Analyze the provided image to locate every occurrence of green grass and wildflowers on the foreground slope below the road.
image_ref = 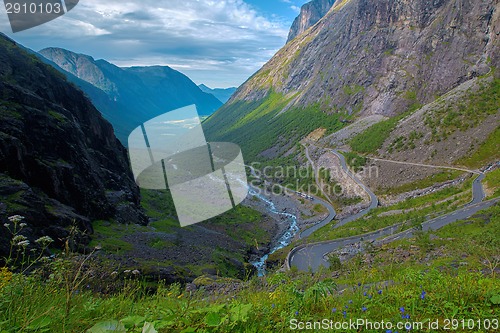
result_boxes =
[0,205,500,332]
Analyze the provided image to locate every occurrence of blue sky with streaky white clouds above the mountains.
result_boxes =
[0,0,308,88]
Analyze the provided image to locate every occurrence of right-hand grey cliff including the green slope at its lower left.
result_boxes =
[204,0,500,159]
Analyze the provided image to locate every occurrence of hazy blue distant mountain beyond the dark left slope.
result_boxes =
[40,48,222,144]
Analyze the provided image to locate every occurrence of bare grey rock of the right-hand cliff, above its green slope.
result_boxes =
[232,0,500,115]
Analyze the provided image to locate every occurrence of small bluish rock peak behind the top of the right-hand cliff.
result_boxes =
[287,0,336,43]
